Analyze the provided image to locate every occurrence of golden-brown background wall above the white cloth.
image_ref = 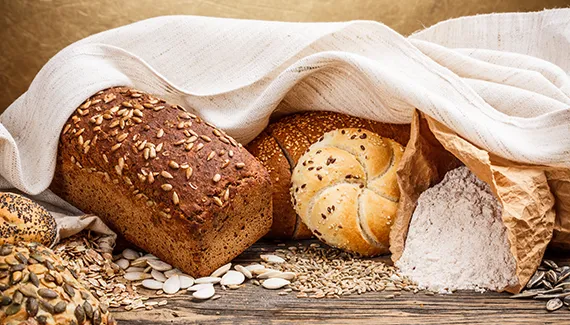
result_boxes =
[0,0,570,111]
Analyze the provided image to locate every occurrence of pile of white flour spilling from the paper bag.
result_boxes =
[396,167,516,293]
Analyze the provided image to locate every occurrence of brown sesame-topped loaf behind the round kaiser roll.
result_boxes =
[247,112,410,239]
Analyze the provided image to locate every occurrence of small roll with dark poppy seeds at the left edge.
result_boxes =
[0,193,57,247]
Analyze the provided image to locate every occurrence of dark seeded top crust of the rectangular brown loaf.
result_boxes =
[61,87,268,226]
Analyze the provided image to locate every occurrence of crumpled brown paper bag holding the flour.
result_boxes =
[390,112,570,293]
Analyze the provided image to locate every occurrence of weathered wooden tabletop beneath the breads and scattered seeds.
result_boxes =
[114,242,570,325]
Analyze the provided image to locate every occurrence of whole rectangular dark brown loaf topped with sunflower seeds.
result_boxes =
[51,88,272,276]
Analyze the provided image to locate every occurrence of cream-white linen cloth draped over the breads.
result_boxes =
[0,9,570,242]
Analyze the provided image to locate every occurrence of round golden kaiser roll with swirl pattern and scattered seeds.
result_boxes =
[291,129,404,256]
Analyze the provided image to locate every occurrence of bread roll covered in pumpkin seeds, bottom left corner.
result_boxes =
[0,242,116,325]
